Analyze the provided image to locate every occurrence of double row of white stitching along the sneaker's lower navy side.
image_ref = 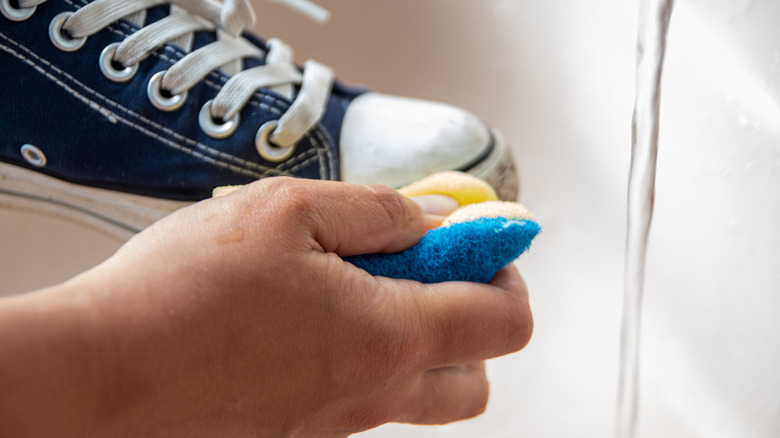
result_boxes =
[0,33,325,178]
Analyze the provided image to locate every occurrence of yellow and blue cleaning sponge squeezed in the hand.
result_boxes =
[344,182,540,283]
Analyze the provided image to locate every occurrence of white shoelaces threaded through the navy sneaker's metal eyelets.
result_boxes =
[19,0,333,147]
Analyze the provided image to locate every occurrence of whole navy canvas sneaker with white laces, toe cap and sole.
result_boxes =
[0,0,517,237]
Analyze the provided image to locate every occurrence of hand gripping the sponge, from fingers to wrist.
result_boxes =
[0,178,533,437]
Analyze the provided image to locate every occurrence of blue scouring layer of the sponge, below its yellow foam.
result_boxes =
[344,217,539,283]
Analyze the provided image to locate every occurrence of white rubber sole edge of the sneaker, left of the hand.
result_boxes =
[0,163,191,240]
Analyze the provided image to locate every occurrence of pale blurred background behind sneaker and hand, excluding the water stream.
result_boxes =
[0,0,780,438]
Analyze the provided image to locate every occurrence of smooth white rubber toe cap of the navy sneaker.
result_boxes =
[340,93,490,187]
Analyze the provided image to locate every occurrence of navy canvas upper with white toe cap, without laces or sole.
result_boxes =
[0,0,512,201]
